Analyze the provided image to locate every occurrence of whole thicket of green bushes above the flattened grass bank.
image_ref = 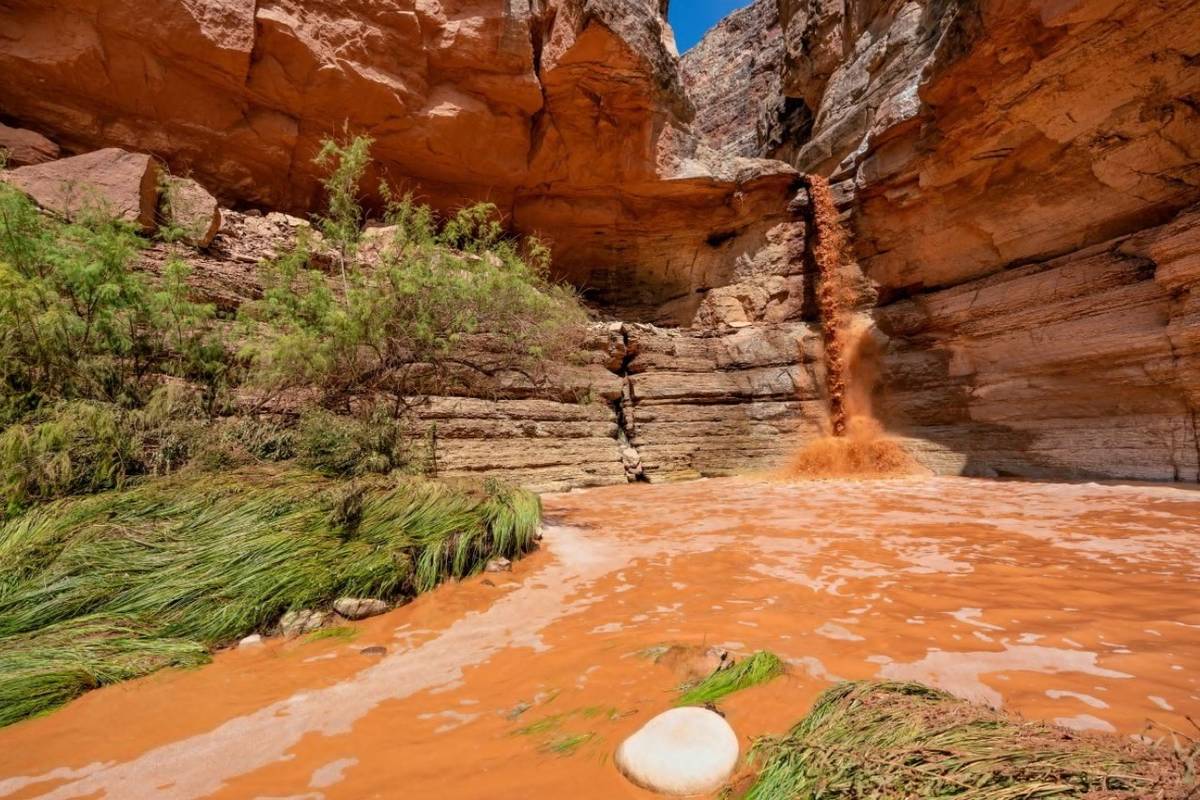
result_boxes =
[0,138,586,515]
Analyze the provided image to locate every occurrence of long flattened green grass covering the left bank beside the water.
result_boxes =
[0,470,541,726]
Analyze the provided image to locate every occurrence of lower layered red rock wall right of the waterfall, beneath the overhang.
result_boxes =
[875,209,1200,481]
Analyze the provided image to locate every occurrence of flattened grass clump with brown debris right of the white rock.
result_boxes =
[744,681,1186,800]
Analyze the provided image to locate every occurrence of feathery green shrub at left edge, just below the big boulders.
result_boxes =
[0,179,226,423]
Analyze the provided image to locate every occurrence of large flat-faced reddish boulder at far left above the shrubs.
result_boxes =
[4,148,158,230]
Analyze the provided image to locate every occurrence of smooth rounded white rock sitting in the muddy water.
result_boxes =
[616,708,738,796]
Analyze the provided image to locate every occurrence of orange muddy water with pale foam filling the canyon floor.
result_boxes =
[0,479,1200,800]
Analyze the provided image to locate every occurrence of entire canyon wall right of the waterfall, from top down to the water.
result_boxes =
[684,0,1200,481]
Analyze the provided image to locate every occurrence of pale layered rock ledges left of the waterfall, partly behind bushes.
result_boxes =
[142,210,824,491]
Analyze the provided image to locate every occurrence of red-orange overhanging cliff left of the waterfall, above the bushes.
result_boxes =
[0,0,796,324]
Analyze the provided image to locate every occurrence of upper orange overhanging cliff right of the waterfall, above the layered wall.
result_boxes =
[685,0,1200,296]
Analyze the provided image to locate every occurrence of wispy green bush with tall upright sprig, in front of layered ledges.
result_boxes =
[244,138,584,416]
